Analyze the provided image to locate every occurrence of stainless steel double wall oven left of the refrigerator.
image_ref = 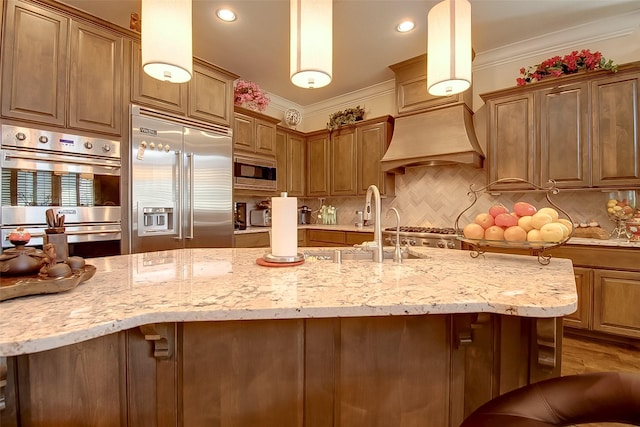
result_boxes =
[0,125,122,258]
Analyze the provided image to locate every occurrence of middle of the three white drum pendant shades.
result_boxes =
[289,0,333,88]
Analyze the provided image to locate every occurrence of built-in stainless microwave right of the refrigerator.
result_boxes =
[233,155,276,191]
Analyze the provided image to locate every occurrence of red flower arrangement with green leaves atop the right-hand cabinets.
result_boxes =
[516,49,618,86]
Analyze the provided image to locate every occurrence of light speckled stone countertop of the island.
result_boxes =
[0,248,577,356]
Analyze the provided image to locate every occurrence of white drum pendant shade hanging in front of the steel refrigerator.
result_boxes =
[141,0,193,83]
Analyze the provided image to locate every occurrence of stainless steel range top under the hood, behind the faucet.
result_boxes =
[382,226,462,249]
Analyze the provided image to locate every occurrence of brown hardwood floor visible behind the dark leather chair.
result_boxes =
[562,335,640,427]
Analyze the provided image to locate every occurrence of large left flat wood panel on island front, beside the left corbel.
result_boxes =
[179,320,304,427]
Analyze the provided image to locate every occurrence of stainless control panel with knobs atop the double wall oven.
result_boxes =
[2,125,120,159]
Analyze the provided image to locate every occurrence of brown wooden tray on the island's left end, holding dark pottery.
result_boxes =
[0,264,96,301]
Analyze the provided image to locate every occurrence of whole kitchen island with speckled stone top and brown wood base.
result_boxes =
[0,248,577,427]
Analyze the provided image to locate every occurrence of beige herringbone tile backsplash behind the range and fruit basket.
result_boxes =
[299,165,614,231]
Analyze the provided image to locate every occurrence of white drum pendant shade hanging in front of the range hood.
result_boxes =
[427,0,472,96]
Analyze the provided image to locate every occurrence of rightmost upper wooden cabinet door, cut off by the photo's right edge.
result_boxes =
[591,72,640,187]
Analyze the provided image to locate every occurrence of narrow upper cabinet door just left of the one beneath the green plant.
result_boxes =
[306,131,330,197]
